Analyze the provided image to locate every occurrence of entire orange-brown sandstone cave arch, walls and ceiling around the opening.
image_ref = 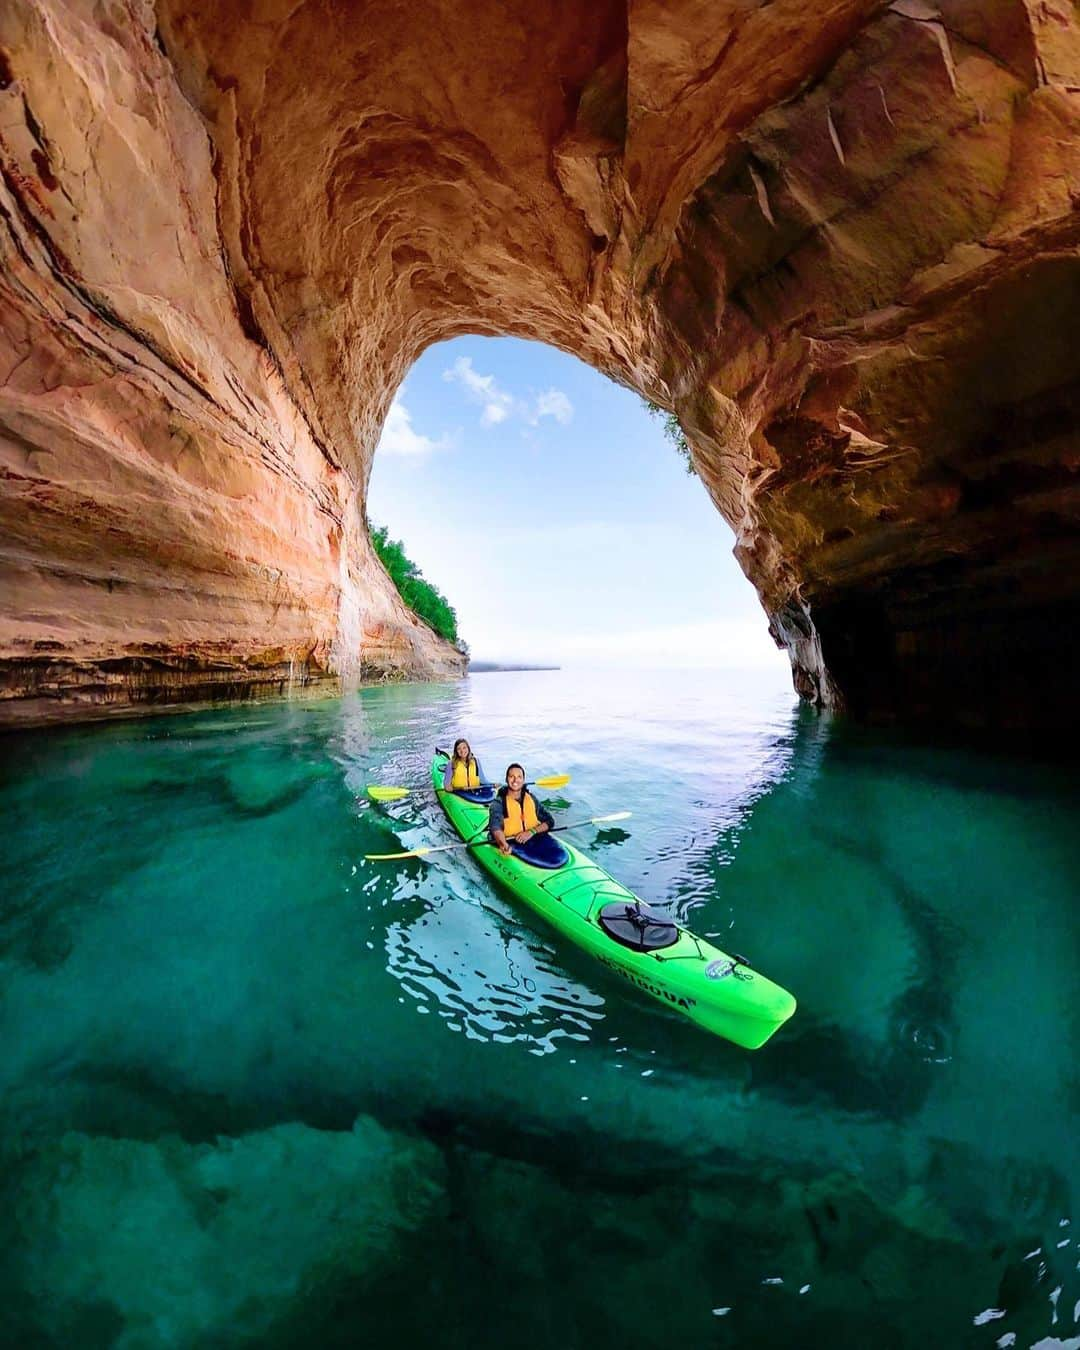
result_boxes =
[0,0,1080,729]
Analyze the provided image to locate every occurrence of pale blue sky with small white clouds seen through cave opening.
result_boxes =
[367,338,787,671]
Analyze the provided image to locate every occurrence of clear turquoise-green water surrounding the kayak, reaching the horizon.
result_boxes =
[0,671,1080,1350]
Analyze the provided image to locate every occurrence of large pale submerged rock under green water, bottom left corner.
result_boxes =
[14,1118,443,1350]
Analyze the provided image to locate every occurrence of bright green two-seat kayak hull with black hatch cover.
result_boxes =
[431,752,795,1050]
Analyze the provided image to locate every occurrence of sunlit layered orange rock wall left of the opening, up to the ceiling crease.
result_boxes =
[0,4,463,722]
